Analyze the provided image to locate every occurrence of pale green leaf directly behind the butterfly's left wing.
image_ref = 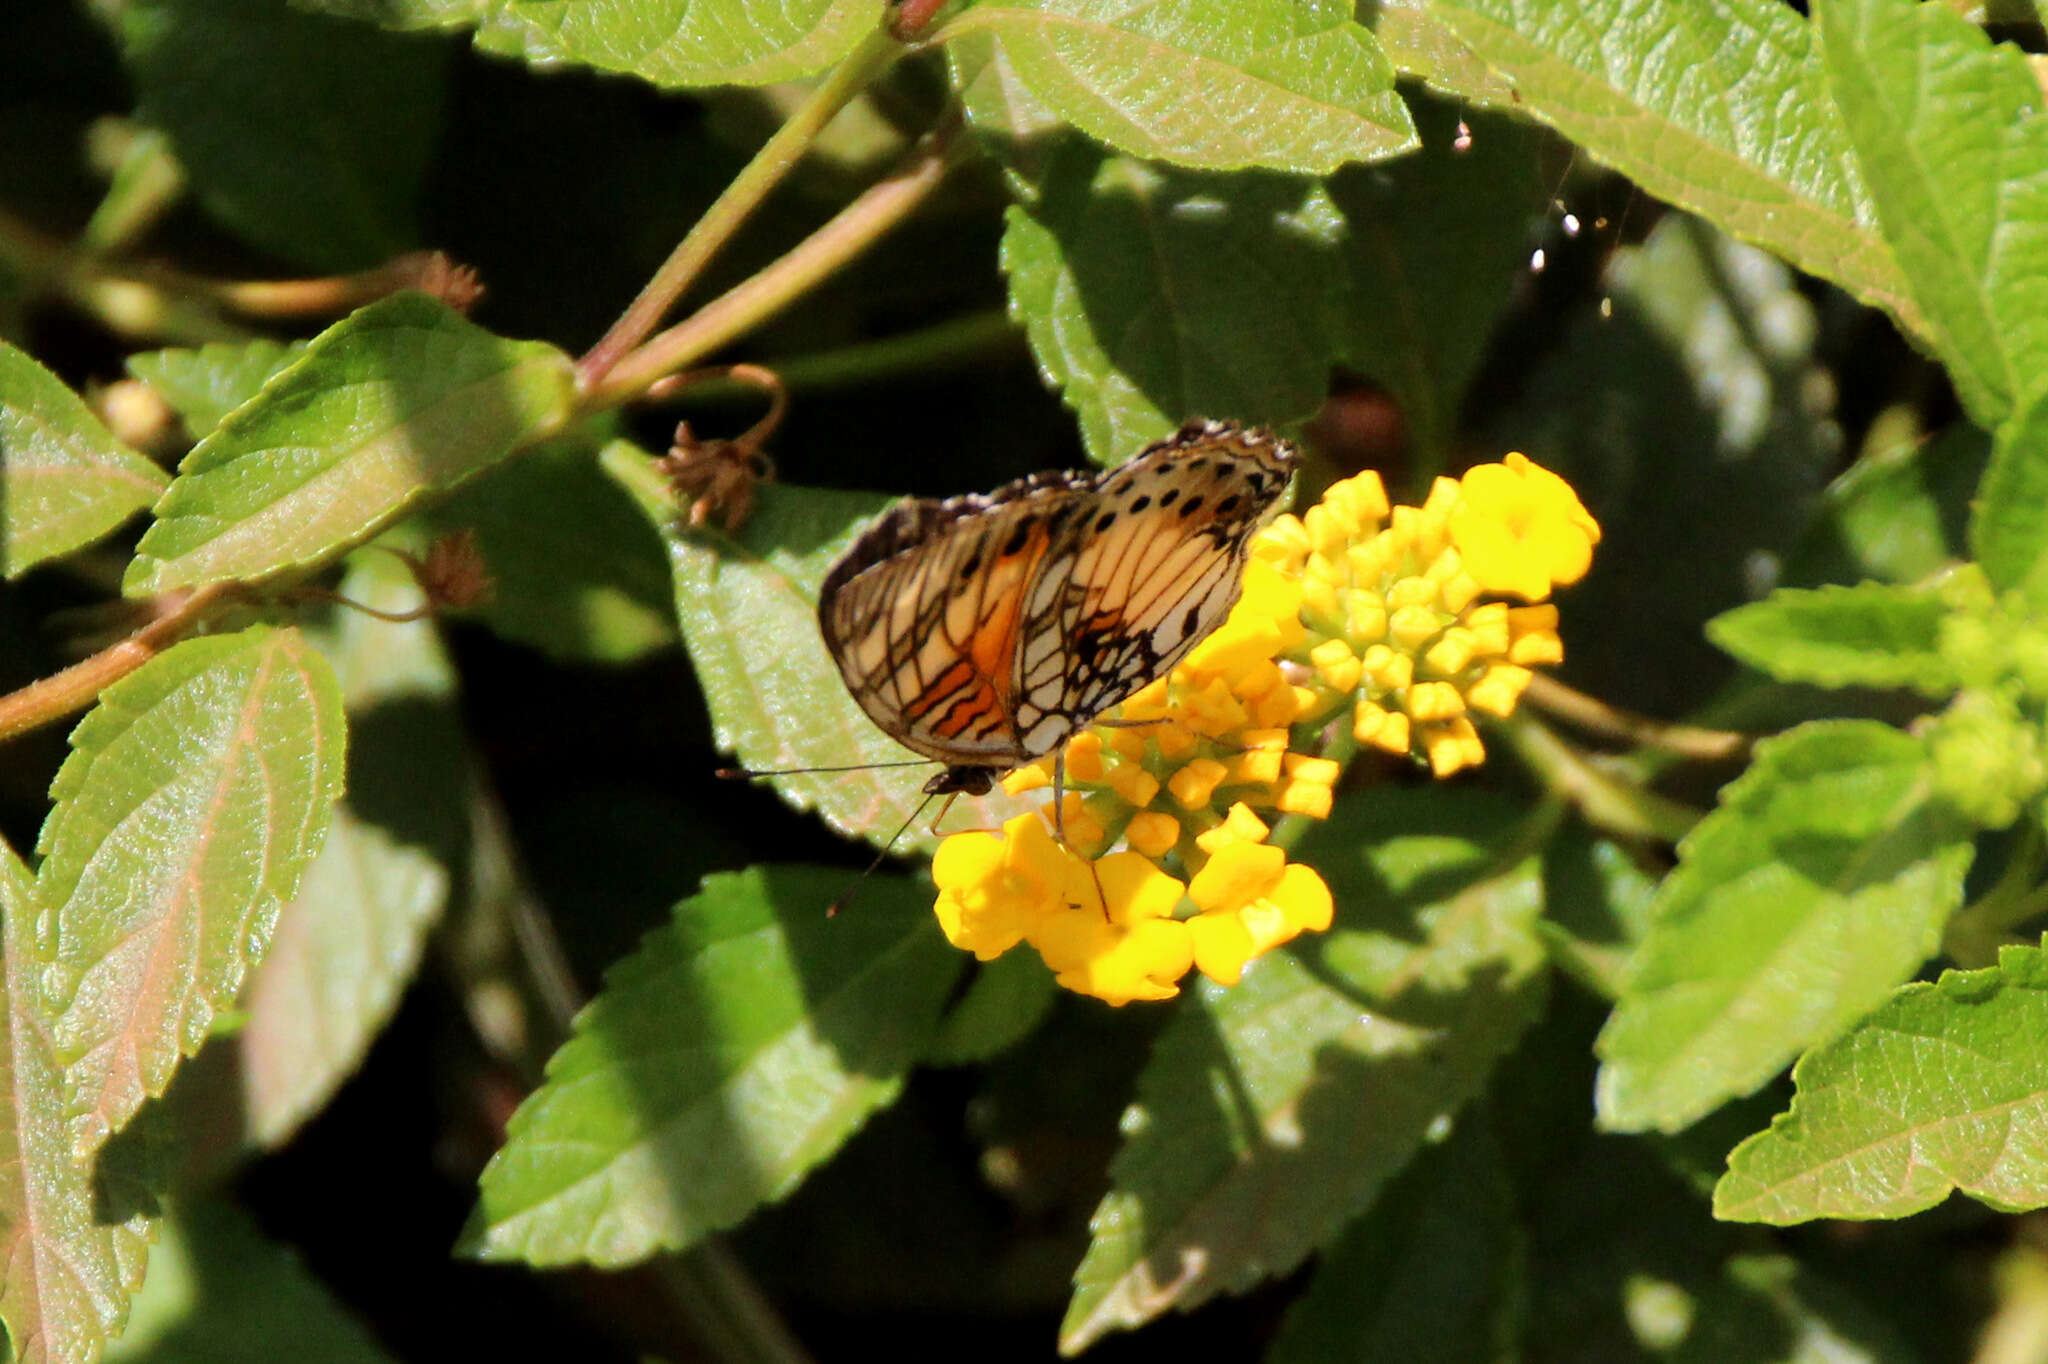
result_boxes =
[604,442,1028,850]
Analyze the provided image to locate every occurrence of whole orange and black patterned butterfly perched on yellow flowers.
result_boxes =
[817,420,1300,797]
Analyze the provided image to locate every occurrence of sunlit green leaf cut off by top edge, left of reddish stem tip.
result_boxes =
[477,0,883,88]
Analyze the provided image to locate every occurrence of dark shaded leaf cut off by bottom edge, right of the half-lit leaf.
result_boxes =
[1266,1120,1522,1364]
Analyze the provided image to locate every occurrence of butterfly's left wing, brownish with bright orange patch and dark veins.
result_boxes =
[817,473,1090,768]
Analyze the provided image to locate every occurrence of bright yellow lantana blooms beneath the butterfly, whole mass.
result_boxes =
[932,455,1599,1004]
